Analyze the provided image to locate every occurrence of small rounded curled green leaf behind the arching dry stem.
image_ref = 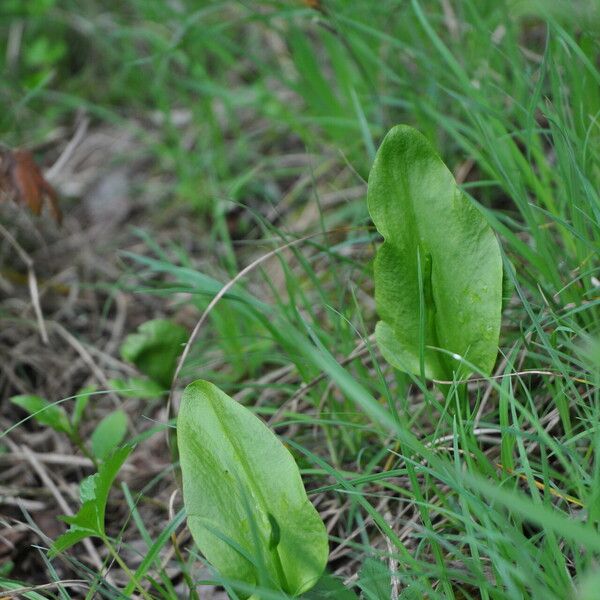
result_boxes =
[121,319,188,388]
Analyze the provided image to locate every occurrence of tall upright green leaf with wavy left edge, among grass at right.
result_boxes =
[368,125,502,379]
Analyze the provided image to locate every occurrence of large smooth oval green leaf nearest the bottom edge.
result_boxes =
[177,381,328,595]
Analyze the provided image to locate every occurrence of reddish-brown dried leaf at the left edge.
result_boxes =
[0,148,62,224]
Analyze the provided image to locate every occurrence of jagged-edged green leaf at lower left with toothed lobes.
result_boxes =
[48,446,133,558]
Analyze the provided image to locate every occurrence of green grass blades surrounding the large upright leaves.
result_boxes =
[0,0,600,600]
